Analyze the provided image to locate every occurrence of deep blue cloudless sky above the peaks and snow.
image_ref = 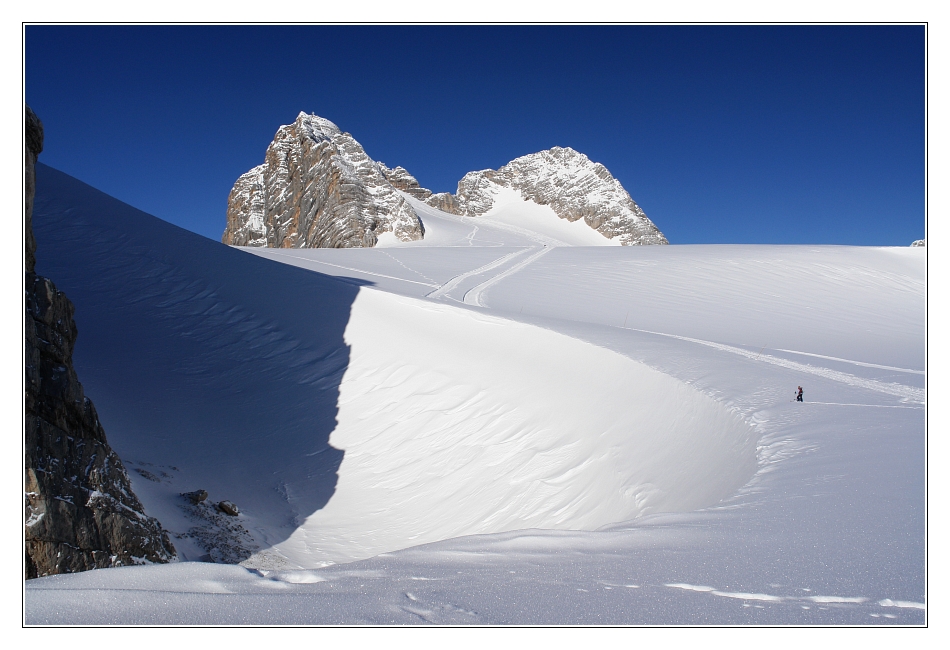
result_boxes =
[26,26,925,246]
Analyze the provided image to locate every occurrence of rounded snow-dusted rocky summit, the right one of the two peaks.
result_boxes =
[455,147,669,246]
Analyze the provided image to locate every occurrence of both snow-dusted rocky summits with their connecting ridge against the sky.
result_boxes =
[222,113,669,248]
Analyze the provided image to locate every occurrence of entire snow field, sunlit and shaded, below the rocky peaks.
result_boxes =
[25,165,927,625]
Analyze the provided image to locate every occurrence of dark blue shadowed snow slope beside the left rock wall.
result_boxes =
[33,164,365,565]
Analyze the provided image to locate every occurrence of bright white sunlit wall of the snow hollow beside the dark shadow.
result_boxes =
[276,290,755,566]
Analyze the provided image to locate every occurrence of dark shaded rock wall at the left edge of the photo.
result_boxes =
[24,108,175,578]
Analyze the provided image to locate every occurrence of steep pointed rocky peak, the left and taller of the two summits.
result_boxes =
[221,113,423,248]
